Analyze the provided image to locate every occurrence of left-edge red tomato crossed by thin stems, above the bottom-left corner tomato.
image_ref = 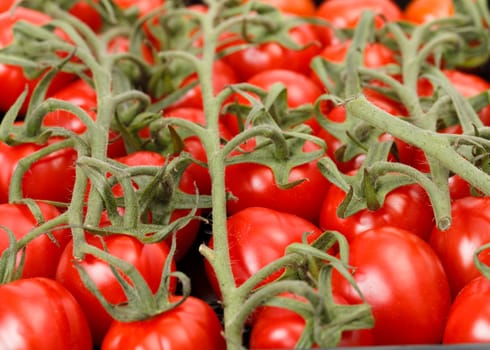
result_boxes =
[0,202,71,278]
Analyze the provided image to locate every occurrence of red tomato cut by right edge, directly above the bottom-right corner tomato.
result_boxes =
[430,197,490,296]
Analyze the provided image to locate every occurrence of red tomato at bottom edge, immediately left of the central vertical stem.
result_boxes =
[101,296,226,350]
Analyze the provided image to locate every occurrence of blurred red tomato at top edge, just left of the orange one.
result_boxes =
[316,0,402,46]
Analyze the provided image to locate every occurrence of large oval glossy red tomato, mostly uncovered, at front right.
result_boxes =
[332,226,451,345]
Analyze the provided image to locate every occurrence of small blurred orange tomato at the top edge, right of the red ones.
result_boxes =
[403,0,454,24]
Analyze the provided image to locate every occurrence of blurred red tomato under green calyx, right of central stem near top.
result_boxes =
[223,21,321,81]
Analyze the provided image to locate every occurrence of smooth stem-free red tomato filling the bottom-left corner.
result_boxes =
[0,277,93,350]
